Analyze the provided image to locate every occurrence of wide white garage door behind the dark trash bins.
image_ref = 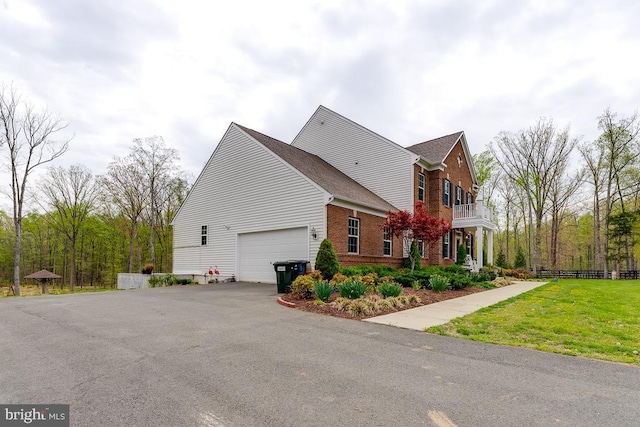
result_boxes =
[238,227,309,283]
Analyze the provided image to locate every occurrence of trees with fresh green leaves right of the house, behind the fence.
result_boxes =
[474,109,640,277]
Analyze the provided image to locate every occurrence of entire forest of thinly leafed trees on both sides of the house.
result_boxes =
[0,85,640,294]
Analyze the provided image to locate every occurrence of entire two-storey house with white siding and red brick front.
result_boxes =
[173,106,492,283]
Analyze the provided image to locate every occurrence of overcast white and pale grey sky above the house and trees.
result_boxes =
[0,0,640,182]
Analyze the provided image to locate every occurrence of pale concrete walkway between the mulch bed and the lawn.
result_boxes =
[364,282,547,331]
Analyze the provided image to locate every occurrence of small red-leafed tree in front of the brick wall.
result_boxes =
[385,202,451,271]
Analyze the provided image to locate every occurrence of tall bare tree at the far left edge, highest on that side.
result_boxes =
[0,85,70,295]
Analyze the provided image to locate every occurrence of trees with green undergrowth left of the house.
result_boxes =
[0,85,189,295]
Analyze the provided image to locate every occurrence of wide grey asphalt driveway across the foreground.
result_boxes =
[0,283,640,427]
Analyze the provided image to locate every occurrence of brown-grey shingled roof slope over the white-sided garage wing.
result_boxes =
[236,123,398,211]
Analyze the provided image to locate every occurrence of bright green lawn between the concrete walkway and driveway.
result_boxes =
[426,279,640,365]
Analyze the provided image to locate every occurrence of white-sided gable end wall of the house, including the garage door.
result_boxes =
[173,124,326,283]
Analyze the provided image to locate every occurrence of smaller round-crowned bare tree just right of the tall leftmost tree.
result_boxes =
[41,165,97,292]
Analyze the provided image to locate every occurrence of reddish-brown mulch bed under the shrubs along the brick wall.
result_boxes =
[281,286,487,320]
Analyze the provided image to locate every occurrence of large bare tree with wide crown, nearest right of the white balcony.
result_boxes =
[490,118,578,274]
